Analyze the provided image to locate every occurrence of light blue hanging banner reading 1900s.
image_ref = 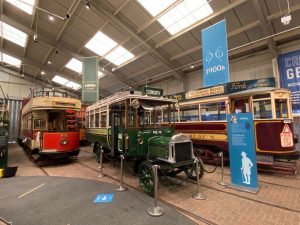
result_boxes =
[202,20,229,87]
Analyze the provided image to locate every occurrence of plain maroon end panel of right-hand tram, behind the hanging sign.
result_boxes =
[255,121,295,153]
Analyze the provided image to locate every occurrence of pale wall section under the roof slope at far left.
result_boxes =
[0,71,39,99]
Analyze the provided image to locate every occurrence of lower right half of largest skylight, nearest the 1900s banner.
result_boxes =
[158,0,213,35]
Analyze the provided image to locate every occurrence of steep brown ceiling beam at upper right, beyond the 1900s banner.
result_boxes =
[252,0,277,57]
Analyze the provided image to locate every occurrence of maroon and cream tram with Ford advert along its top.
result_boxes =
[170,78,299,173]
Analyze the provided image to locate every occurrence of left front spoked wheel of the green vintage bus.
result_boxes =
[139,161,154,195]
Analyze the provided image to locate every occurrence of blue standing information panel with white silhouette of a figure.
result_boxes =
[227,113,258,192]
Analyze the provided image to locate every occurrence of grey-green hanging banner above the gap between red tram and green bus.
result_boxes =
[82,57,99,104]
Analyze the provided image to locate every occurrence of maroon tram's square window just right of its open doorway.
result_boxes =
[253,99,272,119]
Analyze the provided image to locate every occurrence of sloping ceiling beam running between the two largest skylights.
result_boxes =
[93,1,183,82]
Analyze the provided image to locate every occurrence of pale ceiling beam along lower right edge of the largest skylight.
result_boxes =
[155,0,247,48]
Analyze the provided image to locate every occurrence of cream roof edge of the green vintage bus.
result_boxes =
[87,91,178,110]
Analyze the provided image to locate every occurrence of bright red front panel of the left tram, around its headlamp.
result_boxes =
[43,132,79,152]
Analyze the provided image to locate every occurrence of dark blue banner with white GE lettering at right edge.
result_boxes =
[278,50,300,116]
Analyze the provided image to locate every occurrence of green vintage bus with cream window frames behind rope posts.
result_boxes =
[86,91,204,194]
